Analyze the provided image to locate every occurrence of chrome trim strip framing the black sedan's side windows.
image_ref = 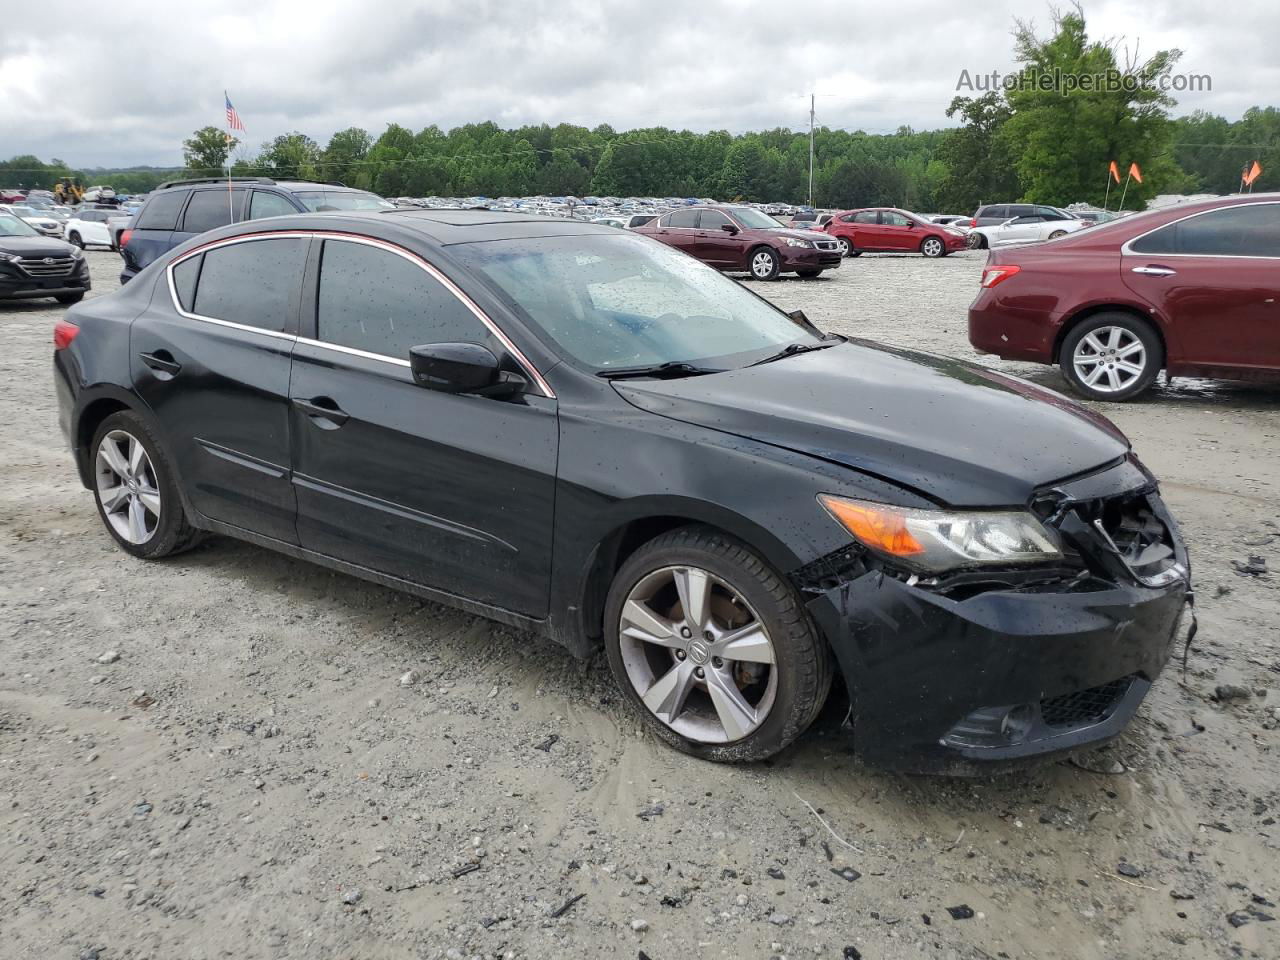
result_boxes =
[165,230,556,399]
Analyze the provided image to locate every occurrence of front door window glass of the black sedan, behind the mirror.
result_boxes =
[316,239,490,360]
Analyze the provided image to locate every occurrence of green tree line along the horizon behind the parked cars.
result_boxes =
[0,6,1280,212]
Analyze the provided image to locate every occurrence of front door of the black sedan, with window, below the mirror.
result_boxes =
[289,238,558,617]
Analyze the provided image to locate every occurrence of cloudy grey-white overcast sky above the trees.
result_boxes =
[0,0,1280,166]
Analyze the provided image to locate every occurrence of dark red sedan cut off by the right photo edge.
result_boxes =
[969,193,1280,401]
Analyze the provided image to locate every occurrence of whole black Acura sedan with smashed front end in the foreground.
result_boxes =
[47,210,1189,769]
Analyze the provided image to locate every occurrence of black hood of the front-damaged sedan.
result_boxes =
[613,342,1129,507]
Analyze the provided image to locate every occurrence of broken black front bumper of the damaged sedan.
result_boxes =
[801,461,1194,773]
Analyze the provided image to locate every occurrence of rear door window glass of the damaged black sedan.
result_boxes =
[192,238,310,333]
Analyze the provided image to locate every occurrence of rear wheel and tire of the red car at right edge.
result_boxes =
[1059,312,1165,402]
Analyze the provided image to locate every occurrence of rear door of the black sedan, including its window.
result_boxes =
[129,237,311,543]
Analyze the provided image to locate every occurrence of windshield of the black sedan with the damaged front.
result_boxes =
[449,234,819,371]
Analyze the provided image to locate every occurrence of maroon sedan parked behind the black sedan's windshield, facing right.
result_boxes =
[635,206,841,280]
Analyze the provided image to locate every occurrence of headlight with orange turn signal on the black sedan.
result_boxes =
[818,494,1062,573]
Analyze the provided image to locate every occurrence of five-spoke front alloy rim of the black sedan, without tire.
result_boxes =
[618,566,778,744]
